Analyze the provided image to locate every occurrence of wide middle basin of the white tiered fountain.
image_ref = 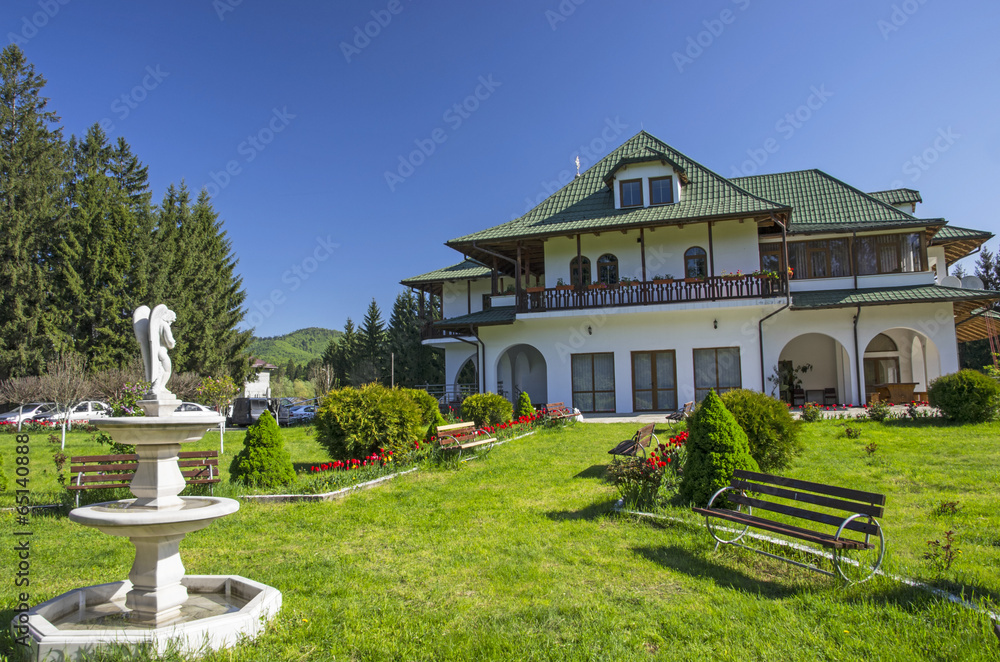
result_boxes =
[69,497,240,538]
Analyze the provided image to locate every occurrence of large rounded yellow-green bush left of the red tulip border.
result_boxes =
[315,383,424,460]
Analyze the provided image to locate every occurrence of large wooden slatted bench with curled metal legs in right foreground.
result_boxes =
[692,469,885,582]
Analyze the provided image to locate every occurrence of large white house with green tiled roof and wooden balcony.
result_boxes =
[402,131,1000,413]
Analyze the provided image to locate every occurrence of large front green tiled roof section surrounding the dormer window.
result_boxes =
[448,131,787,247]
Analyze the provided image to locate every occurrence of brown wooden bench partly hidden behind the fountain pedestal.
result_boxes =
[66,451,219,507]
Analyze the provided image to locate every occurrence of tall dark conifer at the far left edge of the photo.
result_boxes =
[0,45,68,379]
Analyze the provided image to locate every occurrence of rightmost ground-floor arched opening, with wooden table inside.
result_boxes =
[864,327,941,403]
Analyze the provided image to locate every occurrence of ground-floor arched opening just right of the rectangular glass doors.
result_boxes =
[767,333,853,405]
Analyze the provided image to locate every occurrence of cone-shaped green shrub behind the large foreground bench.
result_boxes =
[681,391,760,506]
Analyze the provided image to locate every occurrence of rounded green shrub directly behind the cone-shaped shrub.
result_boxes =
[719,388,802,472]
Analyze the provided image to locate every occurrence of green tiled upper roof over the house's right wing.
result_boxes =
[733,170,932,232]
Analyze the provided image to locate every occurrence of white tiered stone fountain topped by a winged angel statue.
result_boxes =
[12,304,281,660]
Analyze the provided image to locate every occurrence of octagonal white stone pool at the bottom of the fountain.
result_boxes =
[11,575,281,662]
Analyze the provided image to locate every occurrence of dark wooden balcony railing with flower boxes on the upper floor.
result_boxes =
[517,276,788,313]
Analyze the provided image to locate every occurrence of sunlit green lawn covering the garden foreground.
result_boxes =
[0,421,1000,661]
